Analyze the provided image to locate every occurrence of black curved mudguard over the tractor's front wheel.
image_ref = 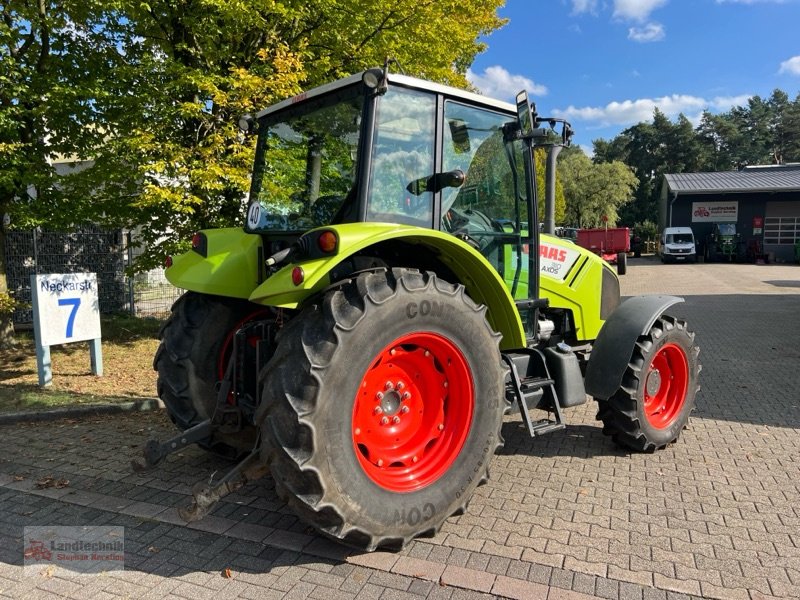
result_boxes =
[584,296,683,400]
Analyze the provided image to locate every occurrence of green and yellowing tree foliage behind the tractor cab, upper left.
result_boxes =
[0,0,503,339]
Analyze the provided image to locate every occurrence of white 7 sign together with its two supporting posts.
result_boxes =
[31,273,103,386]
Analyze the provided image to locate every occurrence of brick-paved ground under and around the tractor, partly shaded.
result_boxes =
[0,259,800,600]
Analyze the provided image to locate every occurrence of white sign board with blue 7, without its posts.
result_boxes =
[33,273,100,346]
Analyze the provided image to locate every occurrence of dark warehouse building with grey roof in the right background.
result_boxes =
[659,164,800,262]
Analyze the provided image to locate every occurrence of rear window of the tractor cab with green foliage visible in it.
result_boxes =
[246,86,364,231]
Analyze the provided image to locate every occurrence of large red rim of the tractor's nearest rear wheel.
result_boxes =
[352,333,474,492]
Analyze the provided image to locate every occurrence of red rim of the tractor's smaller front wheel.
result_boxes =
[644,344,689,429]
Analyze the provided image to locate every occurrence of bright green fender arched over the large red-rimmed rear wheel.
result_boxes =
[250,223,525,349]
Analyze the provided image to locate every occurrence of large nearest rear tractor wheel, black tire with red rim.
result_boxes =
[259,269,505,550]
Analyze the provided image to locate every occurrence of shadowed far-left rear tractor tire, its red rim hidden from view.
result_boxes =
[153,292,264,457]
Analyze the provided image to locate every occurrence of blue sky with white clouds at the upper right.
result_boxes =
[467,0,800,154]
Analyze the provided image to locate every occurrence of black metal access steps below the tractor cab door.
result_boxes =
[502,348,565,437]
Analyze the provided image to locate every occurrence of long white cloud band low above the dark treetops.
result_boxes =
[553,94,751,127]
